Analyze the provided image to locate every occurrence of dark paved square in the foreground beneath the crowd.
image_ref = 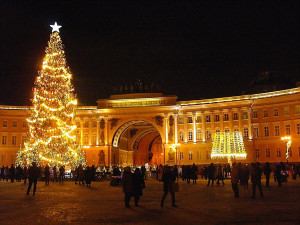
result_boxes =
[0,180,300,225]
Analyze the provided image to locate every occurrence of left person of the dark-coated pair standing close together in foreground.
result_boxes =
[122,166,134,208]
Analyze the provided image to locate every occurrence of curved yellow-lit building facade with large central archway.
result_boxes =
[0,88,300,166]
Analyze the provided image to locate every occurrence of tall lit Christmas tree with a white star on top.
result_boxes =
[16,22,85,166]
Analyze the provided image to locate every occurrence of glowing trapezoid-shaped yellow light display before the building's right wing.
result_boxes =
[211,132,247,161]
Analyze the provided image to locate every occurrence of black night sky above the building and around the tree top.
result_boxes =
[0,0,300,105]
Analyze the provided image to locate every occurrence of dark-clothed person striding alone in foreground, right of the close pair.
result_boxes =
[160,166,177,208]
